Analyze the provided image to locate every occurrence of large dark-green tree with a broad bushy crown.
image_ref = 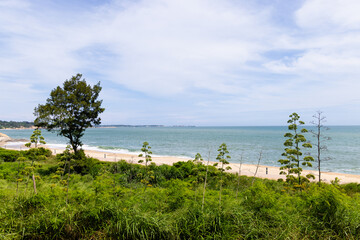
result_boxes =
[34,74,105,154]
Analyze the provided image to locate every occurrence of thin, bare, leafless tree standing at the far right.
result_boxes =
[310,111,331,183]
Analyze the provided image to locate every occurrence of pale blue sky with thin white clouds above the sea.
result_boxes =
[0,0,360,126]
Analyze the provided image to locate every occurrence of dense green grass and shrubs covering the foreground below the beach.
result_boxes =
[0,148,360,239]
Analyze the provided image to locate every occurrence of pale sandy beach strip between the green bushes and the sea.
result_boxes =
[5,144,360,184]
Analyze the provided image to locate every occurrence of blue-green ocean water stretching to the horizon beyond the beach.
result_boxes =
[1,126,360,174]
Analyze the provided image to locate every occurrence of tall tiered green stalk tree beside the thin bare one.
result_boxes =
[278,113,315,185]
